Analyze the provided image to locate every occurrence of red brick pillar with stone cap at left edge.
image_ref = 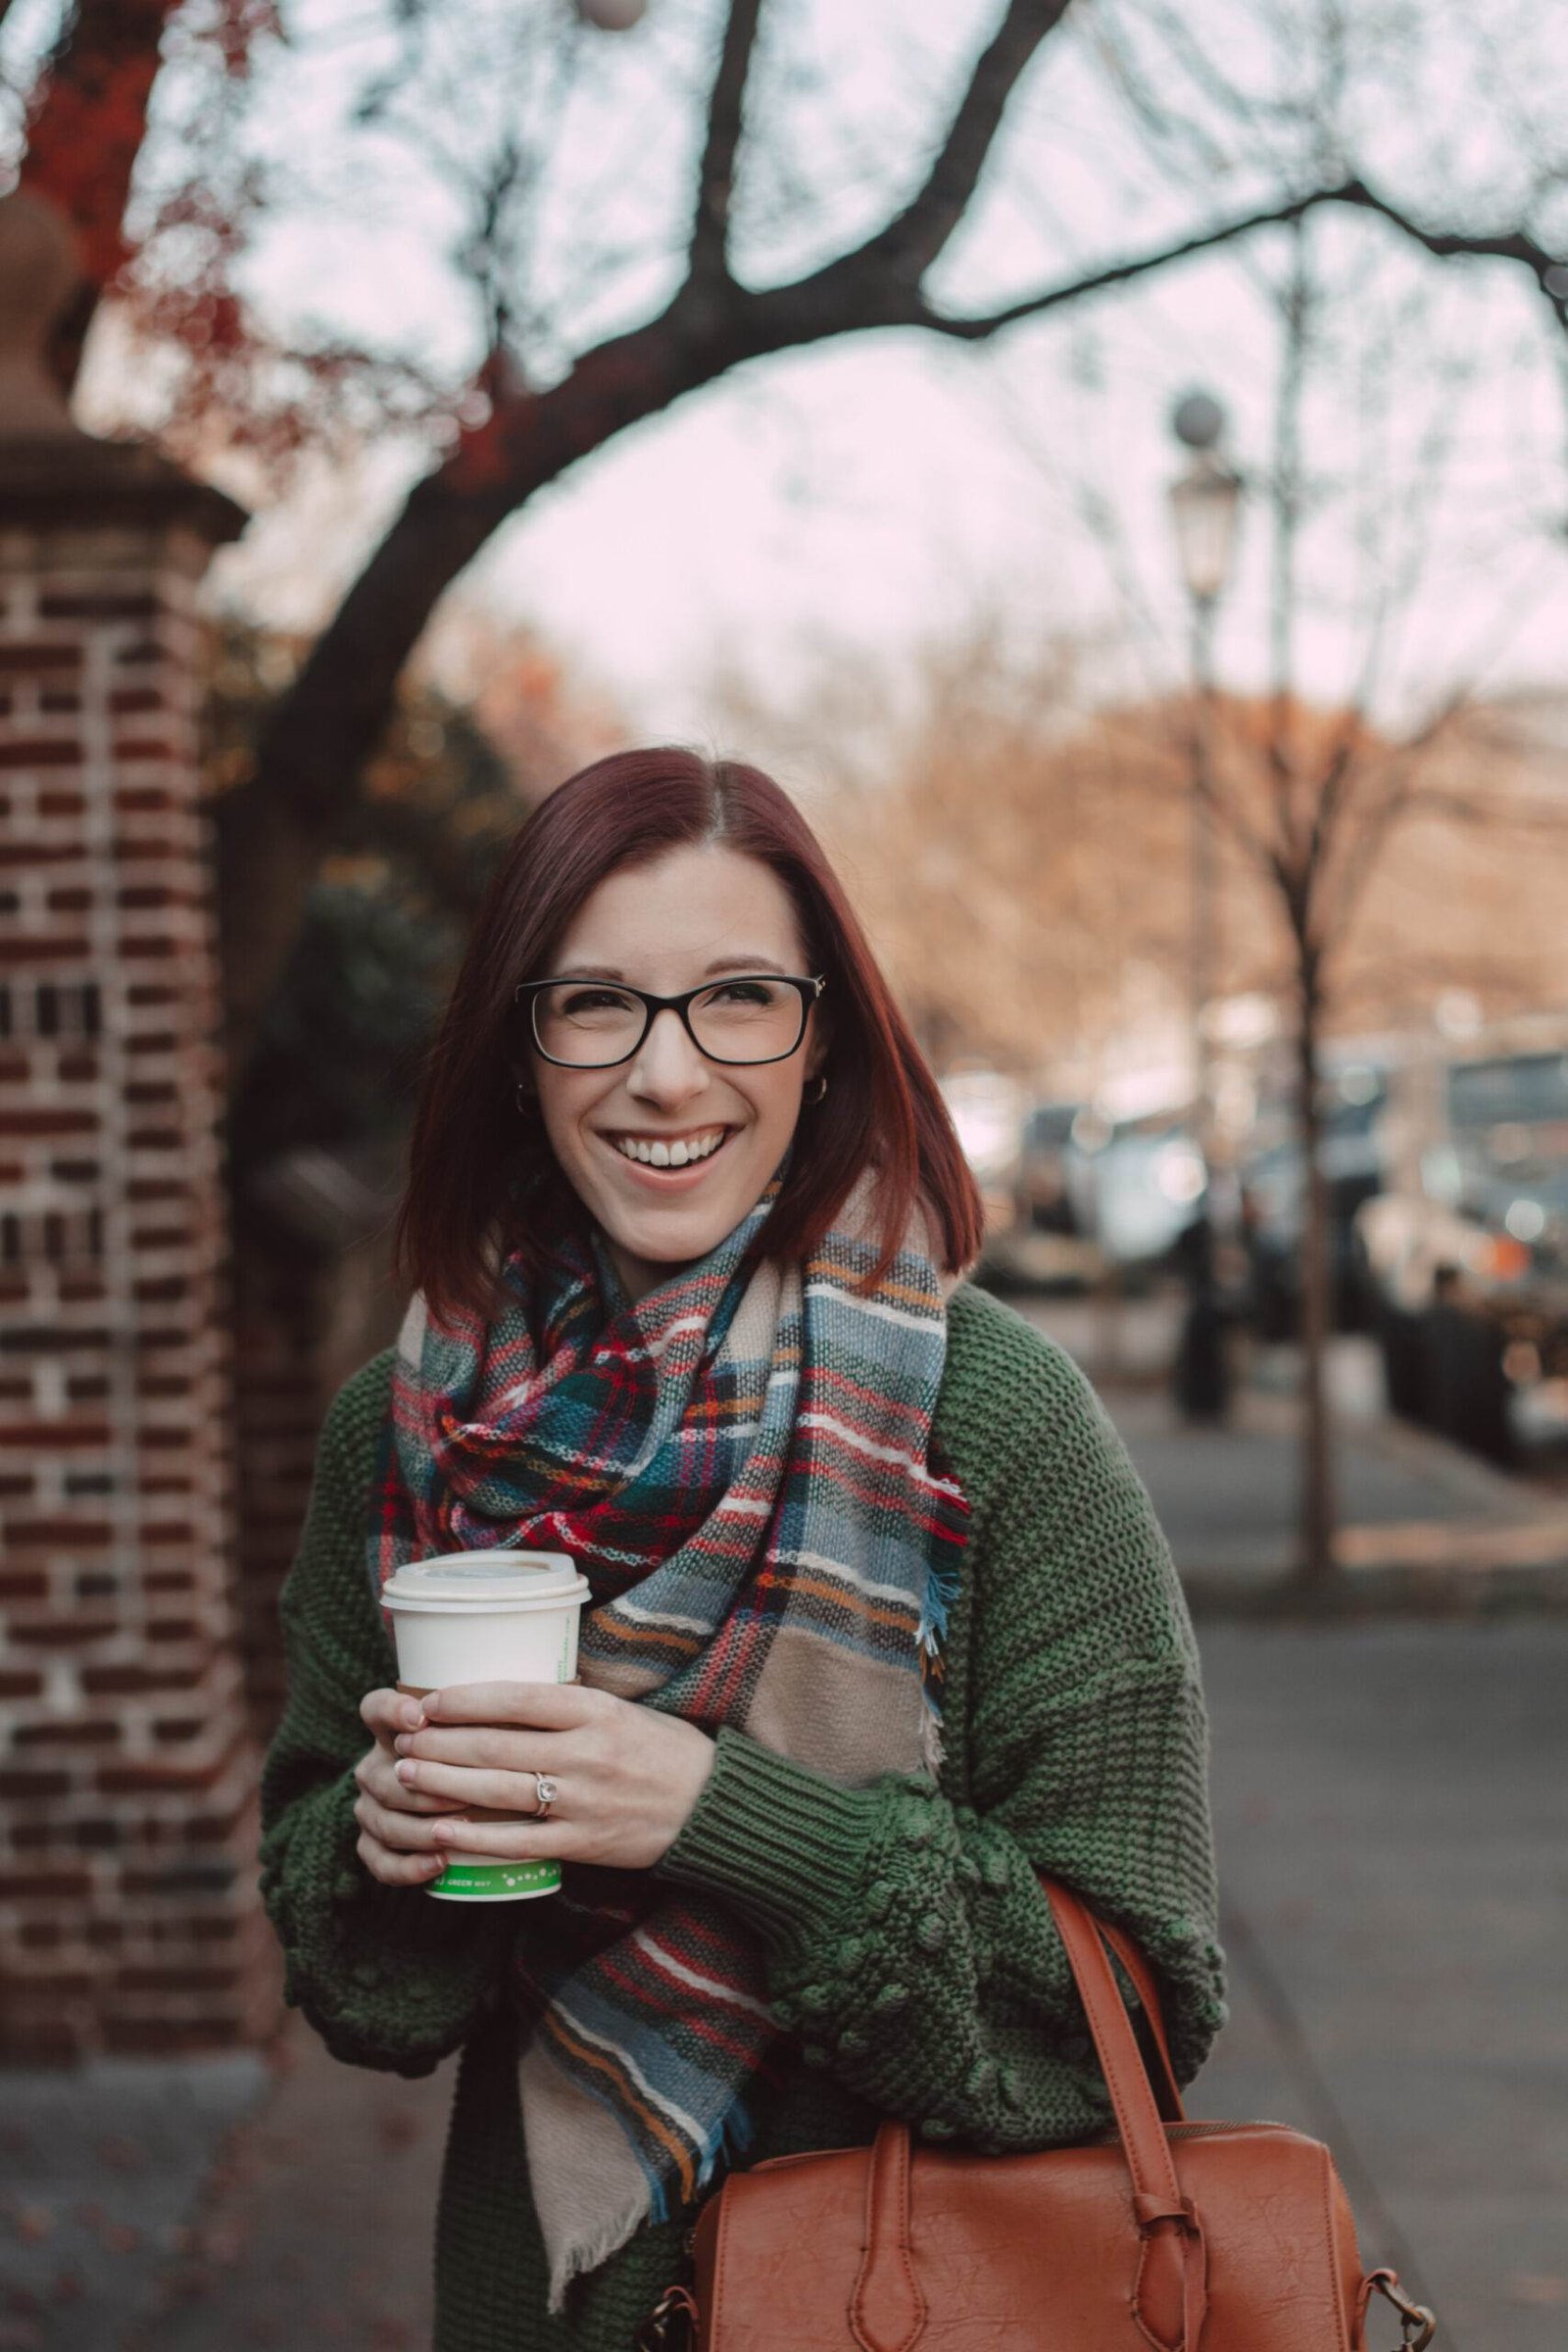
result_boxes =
[0,198,272,2058]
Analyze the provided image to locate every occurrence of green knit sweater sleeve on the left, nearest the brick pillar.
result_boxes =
[261,1357,506,2075]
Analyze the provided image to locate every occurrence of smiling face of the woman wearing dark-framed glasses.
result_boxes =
[529,847,827,1300]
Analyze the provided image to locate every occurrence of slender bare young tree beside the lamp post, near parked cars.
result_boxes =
[1190,221,1566,1594]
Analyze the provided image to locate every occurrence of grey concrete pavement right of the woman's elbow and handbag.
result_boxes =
[1190,1623,1568,2352]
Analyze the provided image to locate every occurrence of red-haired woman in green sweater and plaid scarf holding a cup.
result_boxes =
[264,751,1222,2352]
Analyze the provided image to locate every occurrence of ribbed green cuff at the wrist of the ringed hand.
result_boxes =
[656,1729,882,1942]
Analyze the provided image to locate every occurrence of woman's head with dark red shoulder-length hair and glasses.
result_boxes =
[397,748,980,1310]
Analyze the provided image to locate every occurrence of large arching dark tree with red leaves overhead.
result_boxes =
[6,0,1568,1068]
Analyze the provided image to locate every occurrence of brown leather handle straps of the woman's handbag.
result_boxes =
[849,1877,1208,2352]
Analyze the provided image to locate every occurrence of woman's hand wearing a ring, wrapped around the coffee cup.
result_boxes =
[393,1682,714,1870]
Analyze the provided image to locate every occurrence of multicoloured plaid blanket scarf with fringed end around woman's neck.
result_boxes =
[369,1159,968,2310]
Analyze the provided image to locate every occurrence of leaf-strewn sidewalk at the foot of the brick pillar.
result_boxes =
[0,2011,454,2352]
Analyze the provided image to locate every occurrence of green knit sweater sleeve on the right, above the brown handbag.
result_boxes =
[659,1336,1225,2152]
